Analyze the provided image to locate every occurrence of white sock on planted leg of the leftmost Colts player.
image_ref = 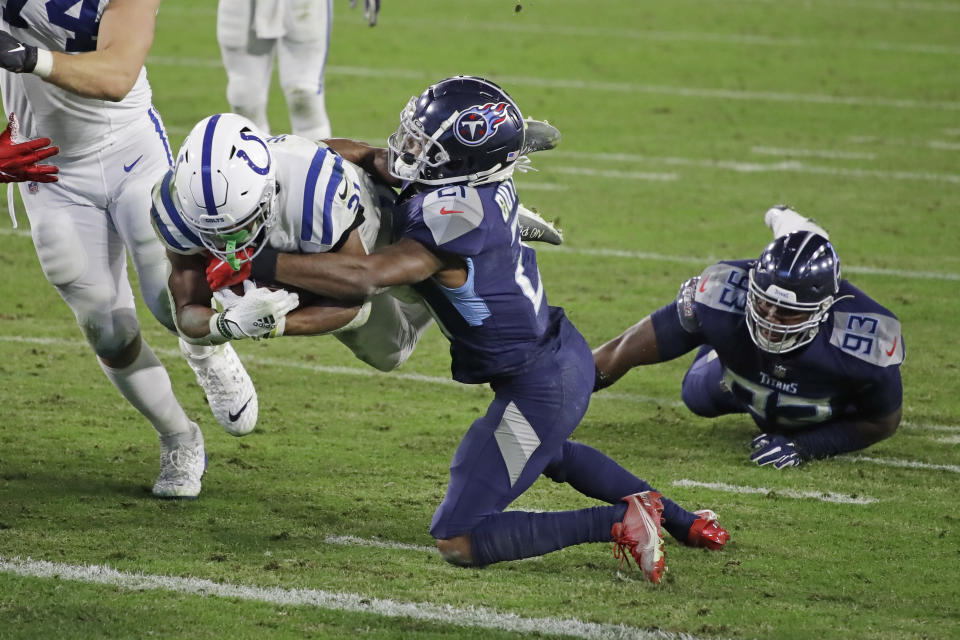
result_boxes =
[97,342,193,436]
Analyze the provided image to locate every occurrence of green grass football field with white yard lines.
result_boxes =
[0,0,960,640]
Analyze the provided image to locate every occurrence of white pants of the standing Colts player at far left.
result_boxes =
[19,109,176,359]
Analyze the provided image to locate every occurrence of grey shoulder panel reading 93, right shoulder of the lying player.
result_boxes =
[830,311,906,367]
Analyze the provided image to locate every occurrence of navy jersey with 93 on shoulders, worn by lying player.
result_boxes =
[654,260,904,429]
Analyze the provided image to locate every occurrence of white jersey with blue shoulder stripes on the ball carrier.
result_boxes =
[150,135,394,262]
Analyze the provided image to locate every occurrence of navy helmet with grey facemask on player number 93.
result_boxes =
[746,231,840,353]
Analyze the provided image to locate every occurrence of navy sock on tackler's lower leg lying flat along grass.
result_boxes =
[471,502,627,567]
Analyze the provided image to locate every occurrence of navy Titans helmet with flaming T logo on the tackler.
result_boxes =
[387,76,524,186]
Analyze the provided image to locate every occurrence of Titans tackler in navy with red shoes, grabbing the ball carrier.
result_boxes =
[225,76,729,582]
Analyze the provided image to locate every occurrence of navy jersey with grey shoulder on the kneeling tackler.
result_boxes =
[394,180,563,383]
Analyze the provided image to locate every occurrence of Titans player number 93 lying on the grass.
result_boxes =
[594,205,904,469]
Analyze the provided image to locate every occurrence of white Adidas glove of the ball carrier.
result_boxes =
[210,280,300,340]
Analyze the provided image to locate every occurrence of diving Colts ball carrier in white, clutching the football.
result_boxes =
[151,113,433,371]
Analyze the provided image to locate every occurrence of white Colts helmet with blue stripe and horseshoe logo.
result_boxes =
[171,113,278,270]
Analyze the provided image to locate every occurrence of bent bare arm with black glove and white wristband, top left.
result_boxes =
[0,0,160,101]
